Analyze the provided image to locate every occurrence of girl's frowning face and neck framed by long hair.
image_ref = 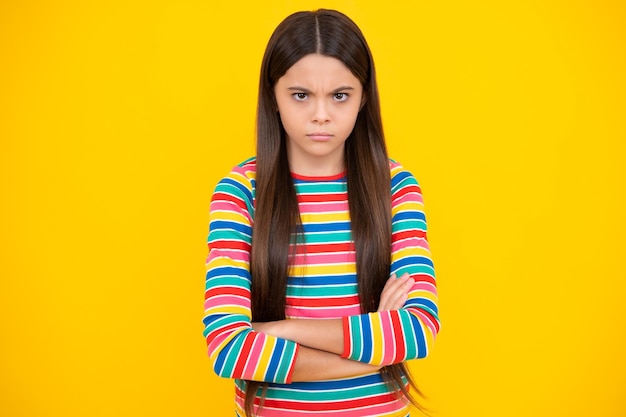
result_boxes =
[274,54,363,176]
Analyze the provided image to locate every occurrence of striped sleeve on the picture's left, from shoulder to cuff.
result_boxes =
[203,164,298,383]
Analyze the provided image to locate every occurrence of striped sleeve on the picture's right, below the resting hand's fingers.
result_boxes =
[342,163,440,366]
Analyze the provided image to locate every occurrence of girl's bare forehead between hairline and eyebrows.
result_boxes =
[278,54,360,86]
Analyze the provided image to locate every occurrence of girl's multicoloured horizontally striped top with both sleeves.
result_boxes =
[204,158,439,417]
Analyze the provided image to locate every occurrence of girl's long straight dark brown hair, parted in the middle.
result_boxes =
[245,9,419,415]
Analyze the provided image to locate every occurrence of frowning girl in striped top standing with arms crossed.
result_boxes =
[204,10,439,417]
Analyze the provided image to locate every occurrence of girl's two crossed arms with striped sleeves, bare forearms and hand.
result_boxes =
[203,162,439,383]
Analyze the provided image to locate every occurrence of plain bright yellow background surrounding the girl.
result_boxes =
[0,0,626,417]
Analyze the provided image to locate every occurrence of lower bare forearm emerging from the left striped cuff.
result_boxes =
[291,346,380,382]
